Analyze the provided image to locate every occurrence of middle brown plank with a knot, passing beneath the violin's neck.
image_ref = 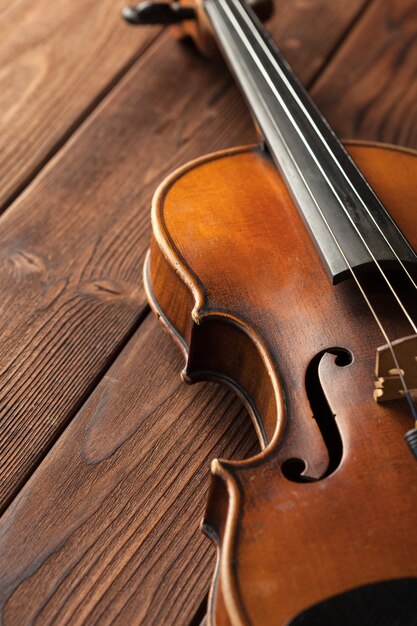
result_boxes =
[0,0,362,505]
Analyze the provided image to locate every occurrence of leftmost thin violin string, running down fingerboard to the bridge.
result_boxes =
[211,0,417,410]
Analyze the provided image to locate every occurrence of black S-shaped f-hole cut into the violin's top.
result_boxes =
[281,348,353,483]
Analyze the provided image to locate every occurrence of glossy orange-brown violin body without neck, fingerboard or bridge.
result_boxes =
[145,144,417,626]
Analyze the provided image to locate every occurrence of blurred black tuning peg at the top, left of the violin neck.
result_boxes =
[122,2,196,26]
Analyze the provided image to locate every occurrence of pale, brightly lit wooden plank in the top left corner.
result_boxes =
[0,0,159,209]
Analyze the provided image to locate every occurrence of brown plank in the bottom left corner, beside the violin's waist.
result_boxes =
[0,317,256,626]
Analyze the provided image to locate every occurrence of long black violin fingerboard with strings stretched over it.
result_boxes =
[204,0,417,282]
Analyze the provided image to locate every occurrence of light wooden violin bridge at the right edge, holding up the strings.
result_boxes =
[374,335,417,402]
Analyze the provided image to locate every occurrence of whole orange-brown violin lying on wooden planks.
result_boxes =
[125,0,417,626]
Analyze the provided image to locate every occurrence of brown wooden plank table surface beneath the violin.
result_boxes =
[0,0,417,626]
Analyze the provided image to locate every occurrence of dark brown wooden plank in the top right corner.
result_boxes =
[312,0,417,147]
